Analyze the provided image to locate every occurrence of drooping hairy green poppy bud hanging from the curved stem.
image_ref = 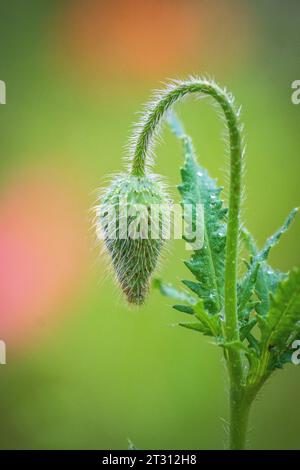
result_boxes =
[97,174,170,304]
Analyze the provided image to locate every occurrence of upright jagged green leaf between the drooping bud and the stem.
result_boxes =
[169,115,227,314]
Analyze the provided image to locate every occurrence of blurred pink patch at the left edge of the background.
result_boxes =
[0,168,87,344]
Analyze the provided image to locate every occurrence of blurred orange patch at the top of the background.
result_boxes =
[58,0,250,80]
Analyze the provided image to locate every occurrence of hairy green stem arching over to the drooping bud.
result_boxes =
[131,79,247,448]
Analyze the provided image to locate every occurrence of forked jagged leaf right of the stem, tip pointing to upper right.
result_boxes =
[238,208,298,317]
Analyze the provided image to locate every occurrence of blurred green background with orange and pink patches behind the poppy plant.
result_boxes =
[0,0,300,449]
